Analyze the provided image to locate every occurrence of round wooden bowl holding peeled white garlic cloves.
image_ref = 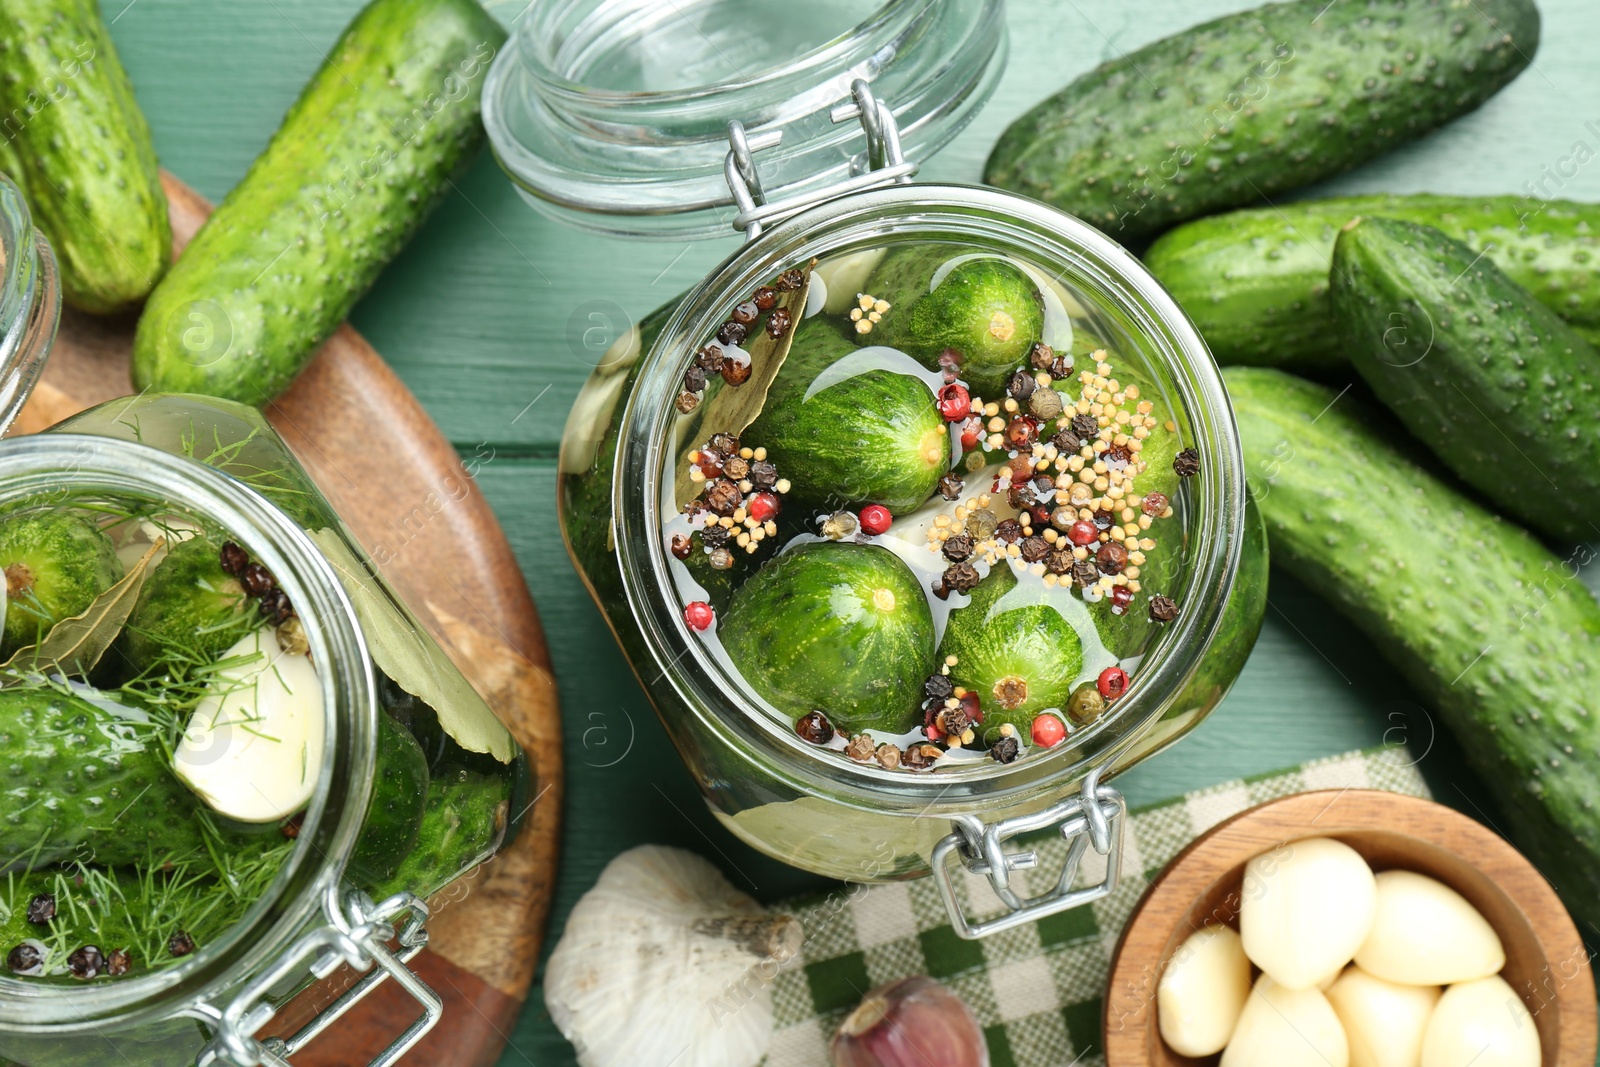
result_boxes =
[1104,789,1597,1067]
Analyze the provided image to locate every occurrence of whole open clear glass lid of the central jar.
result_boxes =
[483,0,1005,237]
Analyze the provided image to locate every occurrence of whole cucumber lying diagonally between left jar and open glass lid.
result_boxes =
[133,0,506,403]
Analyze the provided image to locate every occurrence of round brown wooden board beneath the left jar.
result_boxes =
[11,173,562,1067]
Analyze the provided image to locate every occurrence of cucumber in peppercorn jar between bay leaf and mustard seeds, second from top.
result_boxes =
[742,315,950,515]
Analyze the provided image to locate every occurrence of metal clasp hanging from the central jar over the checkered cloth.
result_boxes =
[933,771,1128,941]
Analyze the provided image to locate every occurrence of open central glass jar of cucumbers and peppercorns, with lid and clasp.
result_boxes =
[485,2,1266,937]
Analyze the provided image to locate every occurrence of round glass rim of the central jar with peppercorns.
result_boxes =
[611,184,1246,808]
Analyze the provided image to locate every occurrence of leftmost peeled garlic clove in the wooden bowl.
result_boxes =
[1155,926,1250,1056]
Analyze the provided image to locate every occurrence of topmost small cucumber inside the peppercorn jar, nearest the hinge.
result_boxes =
[856,245,1045,397]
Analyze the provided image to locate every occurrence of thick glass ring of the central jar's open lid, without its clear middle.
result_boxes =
[483,0,1005,238]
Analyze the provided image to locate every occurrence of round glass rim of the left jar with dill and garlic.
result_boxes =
[0,434,378,1035]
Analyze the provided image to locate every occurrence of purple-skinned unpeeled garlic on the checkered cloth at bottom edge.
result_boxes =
[829,976,989,1067]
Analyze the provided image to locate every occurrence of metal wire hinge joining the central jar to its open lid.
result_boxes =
[723,78,917,240]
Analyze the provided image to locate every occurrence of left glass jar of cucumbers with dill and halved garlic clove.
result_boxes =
[0,177,530,1067]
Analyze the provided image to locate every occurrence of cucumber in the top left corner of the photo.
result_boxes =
[0,0,173,314]
